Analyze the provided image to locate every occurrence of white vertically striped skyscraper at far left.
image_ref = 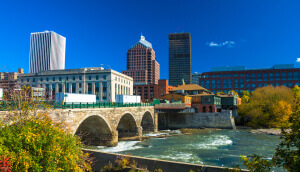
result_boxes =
[29,31,66,73]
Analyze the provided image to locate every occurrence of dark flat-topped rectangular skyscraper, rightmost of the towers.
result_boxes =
[169,33,192,86]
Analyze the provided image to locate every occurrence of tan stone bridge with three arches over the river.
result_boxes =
[49,106,158,146]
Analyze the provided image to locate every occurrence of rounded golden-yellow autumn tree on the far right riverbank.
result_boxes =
[238,86,295,128]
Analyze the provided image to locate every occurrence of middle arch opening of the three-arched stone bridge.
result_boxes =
[117,112,138,138]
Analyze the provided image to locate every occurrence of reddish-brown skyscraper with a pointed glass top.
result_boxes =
[123,36,159,84]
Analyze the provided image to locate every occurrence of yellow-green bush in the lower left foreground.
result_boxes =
[0,94,91,171]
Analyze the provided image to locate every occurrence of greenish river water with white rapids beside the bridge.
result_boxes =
[89,130,282,171]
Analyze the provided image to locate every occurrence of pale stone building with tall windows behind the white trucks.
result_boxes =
[18,67,133,102]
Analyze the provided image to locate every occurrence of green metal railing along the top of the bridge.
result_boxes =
[0,101,153,111]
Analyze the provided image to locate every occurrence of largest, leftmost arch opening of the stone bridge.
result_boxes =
[74,115,112,146]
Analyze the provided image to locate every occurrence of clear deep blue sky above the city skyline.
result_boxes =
[0,0,300,78]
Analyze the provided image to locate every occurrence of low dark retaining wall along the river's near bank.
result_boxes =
[84,149,247,172]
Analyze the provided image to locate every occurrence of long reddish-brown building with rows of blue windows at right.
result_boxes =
[199,64,300,93]
